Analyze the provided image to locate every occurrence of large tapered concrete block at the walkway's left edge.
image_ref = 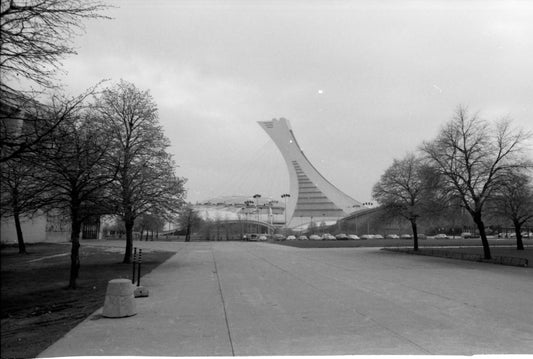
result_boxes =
[102,279,137,318]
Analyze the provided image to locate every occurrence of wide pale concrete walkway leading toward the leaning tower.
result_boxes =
[40,241,533,357]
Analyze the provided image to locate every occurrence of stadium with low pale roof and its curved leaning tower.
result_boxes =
[189,118,369,233]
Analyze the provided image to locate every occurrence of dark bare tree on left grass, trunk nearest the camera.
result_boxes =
[34,107,116,289]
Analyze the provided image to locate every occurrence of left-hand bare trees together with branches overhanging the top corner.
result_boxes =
[0,0,185,288]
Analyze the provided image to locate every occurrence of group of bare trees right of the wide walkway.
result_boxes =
[373,107,533,259]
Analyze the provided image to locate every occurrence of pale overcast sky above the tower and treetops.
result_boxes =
[50,0,533,202]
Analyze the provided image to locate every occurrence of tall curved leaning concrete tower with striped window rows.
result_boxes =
[258,118,363,227]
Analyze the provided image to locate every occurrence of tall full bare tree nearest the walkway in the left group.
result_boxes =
[95,81,185,263]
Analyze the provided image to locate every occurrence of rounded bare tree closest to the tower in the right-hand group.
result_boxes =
[372,154,438,251]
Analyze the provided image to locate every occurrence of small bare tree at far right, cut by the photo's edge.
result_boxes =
[489,170,533,250]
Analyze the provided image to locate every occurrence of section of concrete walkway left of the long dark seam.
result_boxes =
[39,242,232,357]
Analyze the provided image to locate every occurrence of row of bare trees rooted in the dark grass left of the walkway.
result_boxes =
[1,81,185,287]
